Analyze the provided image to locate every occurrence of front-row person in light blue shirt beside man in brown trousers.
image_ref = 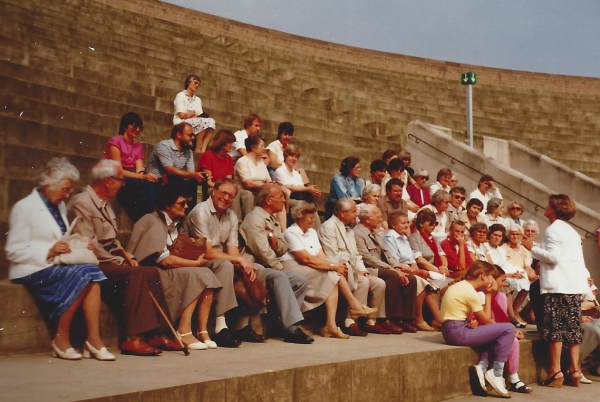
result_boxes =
[382,211,442,331]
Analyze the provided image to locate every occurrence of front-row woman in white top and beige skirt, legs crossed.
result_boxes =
[279,201,377,339]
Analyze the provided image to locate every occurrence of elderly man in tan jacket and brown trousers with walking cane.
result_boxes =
[67,159,181,356]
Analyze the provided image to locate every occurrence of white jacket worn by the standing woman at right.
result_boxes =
[531,219,590,294]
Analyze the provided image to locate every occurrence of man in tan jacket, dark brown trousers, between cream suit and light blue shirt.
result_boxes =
[353,205,417,334]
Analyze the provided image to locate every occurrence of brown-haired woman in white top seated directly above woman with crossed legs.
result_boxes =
[275,144,321,226]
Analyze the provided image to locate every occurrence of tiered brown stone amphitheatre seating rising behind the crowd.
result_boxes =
[0,0,600,400]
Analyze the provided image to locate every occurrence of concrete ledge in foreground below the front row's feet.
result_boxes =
[0,326,545,402]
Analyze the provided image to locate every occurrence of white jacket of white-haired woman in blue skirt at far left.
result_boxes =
[4,189,69,279]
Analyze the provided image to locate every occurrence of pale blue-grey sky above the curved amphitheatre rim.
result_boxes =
[168,0,600,78]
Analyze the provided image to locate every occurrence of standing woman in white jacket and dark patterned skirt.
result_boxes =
[522,194,589,387]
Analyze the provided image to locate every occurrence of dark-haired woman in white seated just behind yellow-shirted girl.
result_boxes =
[487,223,529,328]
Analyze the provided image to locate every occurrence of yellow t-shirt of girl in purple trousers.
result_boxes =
[441,281,483,322]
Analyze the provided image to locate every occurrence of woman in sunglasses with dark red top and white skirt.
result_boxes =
[408,207,452,288]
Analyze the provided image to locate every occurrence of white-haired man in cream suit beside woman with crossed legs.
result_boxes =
[318,198,385,336]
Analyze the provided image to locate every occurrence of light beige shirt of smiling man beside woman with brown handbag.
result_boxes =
[188,197,238,252]
